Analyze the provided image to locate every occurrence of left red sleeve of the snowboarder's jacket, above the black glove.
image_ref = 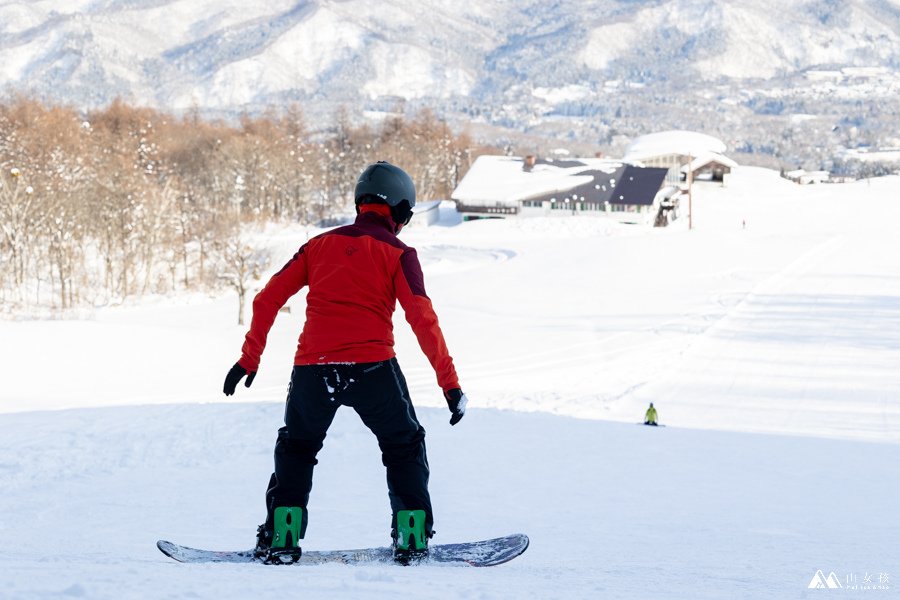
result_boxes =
[238,244,309,372]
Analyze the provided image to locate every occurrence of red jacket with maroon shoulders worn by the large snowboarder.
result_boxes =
[238,204,459,392]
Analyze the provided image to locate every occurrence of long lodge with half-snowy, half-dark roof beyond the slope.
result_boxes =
[451,155,675,224]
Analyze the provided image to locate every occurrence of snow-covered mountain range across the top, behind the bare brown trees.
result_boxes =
[0,0,900,165]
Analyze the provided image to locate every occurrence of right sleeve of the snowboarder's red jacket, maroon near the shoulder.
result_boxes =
[394,248,459,392]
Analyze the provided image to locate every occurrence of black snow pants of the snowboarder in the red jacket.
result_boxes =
[266,358,434,536]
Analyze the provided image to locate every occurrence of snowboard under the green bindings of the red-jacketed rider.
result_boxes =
[156,533,528,567]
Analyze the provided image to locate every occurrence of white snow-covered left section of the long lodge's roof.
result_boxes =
[451,155,622,206]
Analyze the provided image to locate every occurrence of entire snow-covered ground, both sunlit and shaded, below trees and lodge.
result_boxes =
[0,168,900,599]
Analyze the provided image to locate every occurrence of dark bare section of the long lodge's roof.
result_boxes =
[512,163,668,206]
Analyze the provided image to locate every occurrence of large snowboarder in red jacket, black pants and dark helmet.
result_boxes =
[223,161,468,564]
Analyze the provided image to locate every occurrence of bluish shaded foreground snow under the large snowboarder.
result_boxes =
[0,402,900,600]
